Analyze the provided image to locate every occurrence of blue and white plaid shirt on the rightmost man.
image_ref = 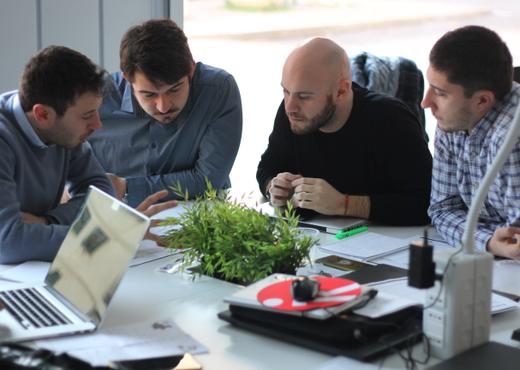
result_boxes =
[428,83,520,250]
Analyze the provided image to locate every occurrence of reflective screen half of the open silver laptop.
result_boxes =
[45,186,149,324]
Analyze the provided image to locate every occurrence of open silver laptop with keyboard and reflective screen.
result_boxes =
[0,186,150,341]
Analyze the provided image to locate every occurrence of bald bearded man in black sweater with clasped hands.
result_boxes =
[257,38,432,225]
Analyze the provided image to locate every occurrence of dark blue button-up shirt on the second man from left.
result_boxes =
[89,63,242,206]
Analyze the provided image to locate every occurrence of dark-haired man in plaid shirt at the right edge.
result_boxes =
[422,26,520,259]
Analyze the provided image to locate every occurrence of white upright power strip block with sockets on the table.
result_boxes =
[423,250,493,359]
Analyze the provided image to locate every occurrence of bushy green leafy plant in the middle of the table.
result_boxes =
[163,184,317,285]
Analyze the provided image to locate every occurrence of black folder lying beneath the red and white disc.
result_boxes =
[218,305,422,361]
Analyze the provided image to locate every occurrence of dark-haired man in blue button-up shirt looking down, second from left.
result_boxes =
[89,20,242,205]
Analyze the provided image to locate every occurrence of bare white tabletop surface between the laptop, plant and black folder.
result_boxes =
[0,221,520,370]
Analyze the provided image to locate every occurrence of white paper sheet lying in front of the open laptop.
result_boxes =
[35,320,208,366]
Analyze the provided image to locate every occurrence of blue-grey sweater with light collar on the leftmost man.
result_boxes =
[0,91,113,263]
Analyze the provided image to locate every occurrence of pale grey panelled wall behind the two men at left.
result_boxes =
[0,0,183,92]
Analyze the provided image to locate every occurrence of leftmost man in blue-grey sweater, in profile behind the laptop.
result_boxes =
[0,46,177,263]
